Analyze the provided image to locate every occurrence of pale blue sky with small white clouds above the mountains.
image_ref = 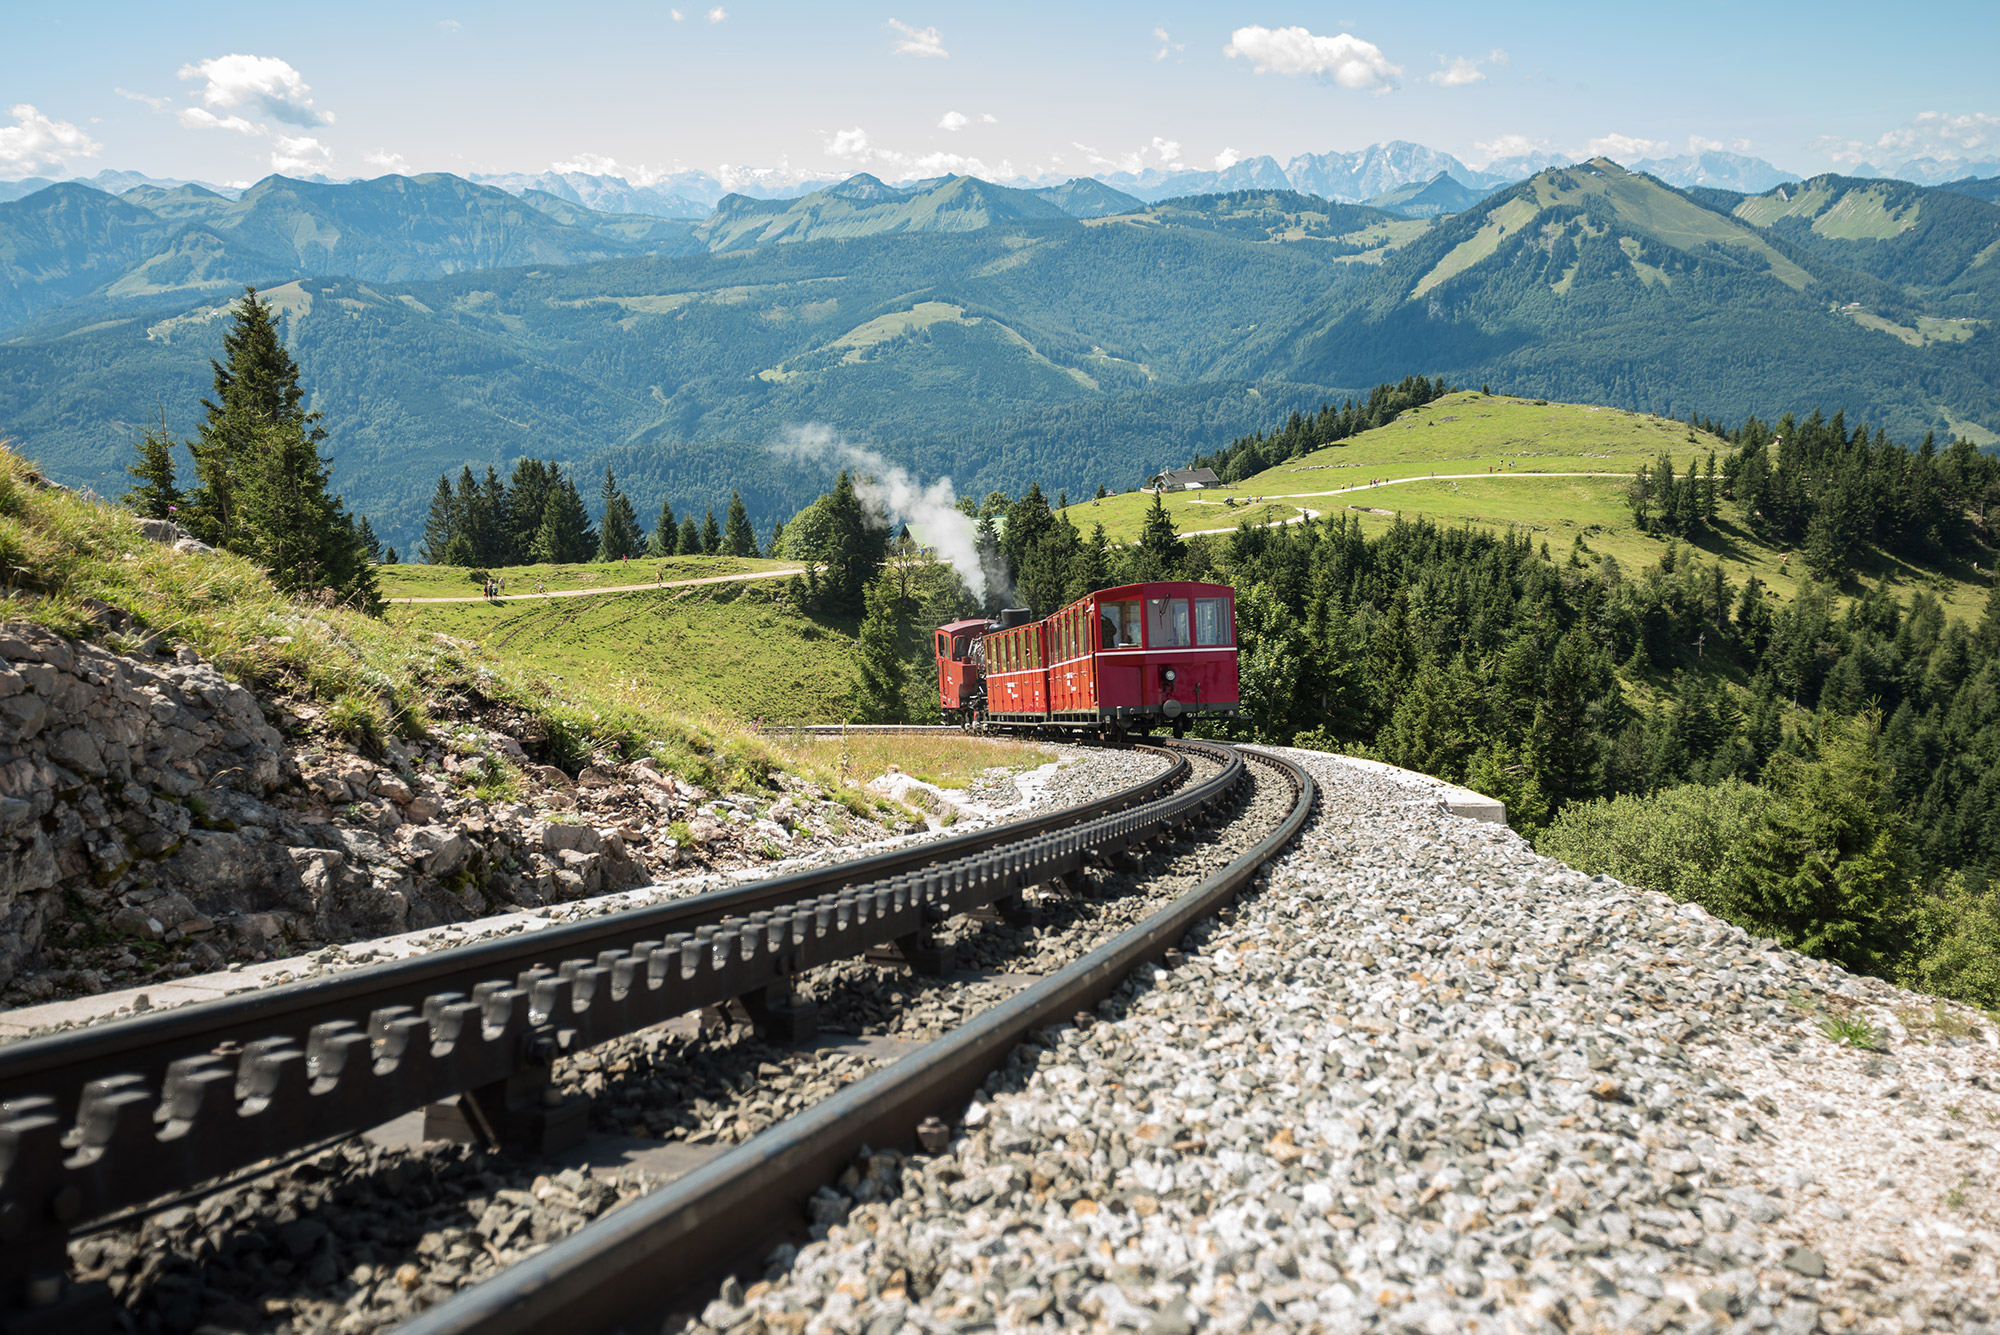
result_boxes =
[0,0,2000,182]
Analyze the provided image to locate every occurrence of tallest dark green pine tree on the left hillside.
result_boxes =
[184,288,326,550]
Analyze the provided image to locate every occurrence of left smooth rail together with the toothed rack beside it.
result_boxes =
[0,743,1312,1333]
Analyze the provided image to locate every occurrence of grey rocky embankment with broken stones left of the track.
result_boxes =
[0,622,922,1005]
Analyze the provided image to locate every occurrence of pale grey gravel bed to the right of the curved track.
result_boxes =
[690,751,2000,1335]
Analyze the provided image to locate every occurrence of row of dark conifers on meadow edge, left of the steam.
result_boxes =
[420,458,762,570]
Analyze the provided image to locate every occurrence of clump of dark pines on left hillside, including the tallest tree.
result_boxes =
[122,288,386,610]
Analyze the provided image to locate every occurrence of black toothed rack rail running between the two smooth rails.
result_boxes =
[0,747,1244,1335]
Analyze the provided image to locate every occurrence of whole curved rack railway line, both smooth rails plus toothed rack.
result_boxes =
[0,741,1314,1335]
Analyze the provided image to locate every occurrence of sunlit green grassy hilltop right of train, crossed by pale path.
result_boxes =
[1068,392,1986,620]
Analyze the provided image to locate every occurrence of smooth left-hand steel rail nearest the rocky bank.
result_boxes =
[0,739,1190,1119]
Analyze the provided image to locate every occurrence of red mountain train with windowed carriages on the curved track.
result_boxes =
[934,582,1236,737]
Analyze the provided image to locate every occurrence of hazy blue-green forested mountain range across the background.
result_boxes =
[0,160,2000,546]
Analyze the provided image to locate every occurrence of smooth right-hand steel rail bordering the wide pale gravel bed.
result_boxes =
[398,751,1316,1335]
